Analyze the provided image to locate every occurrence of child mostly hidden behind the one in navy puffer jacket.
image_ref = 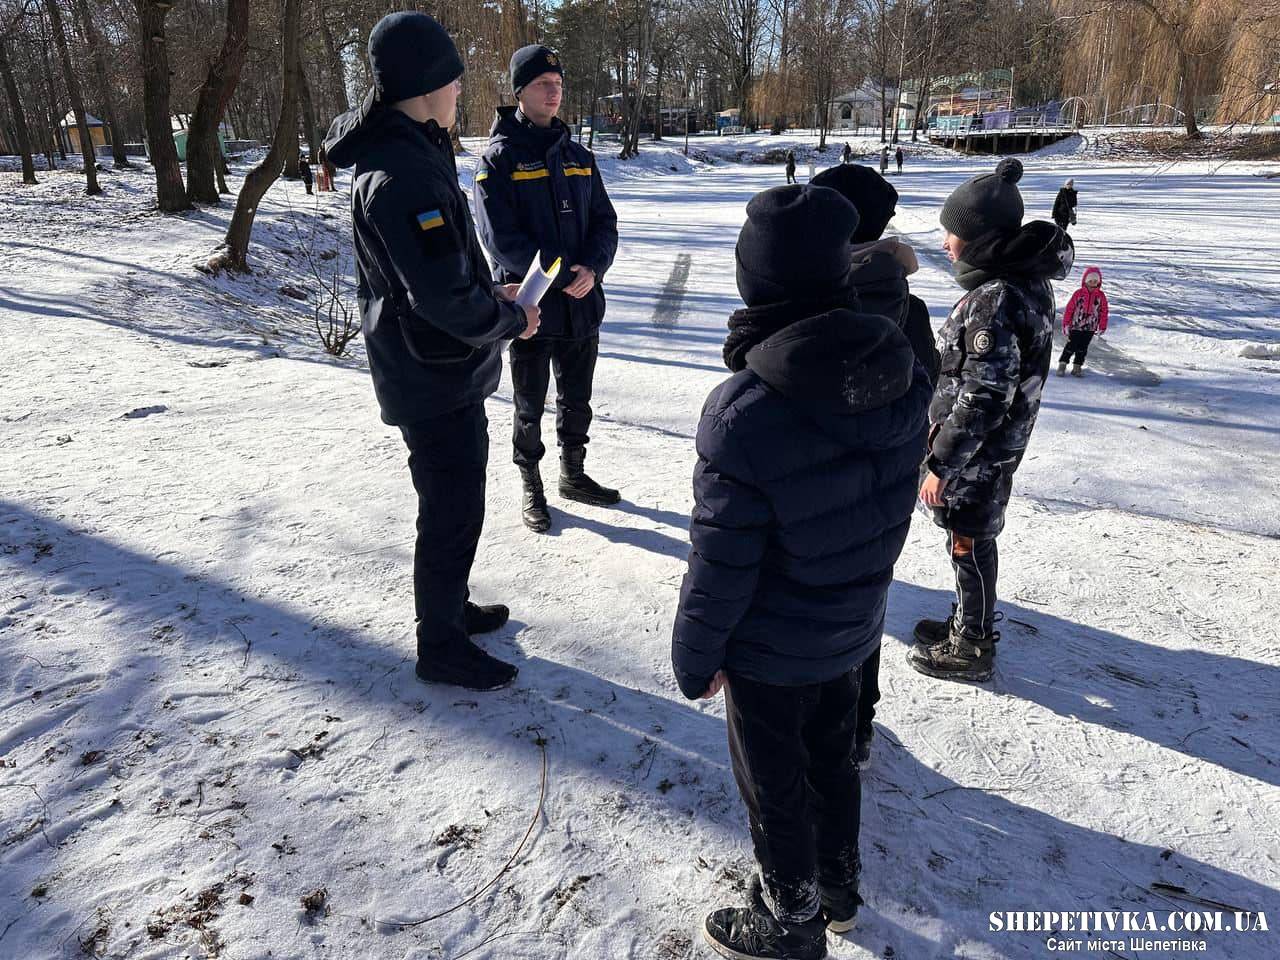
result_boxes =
[813,164,941,763]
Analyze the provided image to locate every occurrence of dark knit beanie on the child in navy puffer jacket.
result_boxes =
[735,183,858,307]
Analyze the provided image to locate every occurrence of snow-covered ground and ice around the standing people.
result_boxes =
[0,138,1280,960]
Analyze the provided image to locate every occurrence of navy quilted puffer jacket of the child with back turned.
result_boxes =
[672,305,929,699]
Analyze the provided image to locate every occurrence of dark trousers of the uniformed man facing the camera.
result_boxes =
[511,337,600,467]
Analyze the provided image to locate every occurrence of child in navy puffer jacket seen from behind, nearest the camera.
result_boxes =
[672,184,929,960]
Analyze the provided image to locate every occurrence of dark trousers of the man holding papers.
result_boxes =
[401,403,489,659]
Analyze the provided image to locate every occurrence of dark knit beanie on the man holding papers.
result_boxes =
[369,10,462,104]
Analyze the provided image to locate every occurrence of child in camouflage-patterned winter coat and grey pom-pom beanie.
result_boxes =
[909,159,1074,681]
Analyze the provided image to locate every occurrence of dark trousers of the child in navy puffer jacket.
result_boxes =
[724,669,863,923]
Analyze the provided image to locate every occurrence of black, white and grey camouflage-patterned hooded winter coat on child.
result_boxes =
[927,220,1075,538]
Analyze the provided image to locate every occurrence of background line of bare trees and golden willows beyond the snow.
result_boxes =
[0,0,1280,213]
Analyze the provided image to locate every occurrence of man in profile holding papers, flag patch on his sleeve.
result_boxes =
[325,12,539,690]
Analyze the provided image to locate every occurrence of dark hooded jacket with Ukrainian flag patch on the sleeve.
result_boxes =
[325,95,525,425]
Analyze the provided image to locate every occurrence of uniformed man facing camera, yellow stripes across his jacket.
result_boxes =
[475,45,620,532]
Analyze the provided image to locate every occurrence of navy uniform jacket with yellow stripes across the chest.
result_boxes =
[475,106,618,339]
